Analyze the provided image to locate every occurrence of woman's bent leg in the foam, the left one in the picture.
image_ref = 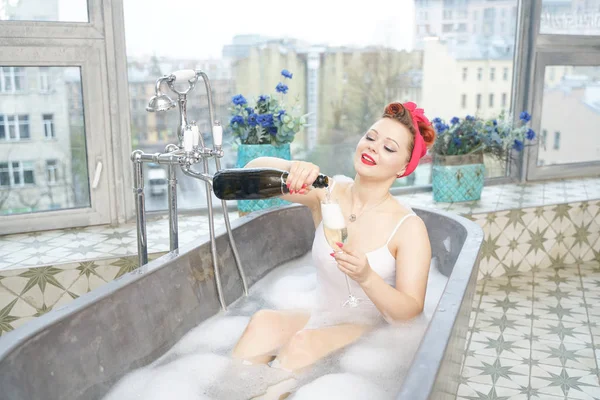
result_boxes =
[233,310,310,364]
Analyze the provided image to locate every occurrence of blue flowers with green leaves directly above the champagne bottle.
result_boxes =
[229,69,308,145]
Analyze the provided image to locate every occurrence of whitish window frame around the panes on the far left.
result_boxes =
[0,0,135,234]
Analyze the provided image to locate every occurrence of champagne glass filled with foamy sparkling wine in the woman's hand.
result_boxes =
[321,198,360,307]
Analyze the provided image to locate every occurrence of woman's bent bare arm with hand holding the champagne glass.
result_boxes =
[335,217,431,321]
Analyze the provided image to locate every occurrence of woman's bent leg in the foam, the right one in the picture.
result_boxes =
[276,324,370,371]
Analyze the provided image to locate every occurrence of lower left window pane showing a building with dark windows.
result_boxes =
[0,67,90,215]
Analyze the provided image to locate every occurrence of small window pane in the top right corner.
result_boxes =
[540,0,600,35]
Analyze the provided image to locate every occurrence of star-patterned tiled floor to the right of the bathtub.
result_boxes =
[458,262,600,400]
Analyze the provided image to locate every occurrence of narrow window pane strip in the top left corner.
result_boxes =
[0,0,89,22]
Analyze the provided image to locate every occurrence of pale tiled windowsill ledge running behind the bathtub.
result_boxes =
[0,177,600,271]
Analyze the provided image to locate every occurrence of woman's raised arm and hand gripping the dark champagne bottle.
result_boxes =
[244,157,322,209]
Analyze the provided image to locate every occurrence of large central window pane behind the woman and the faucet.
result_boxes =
[123,0,517,210]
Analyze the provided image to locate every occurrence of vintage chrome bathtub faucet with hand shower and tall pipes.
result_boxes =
[131,69,248,310]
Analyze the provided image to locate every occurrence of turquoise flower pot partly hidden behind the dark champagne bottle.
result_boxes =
[236,143,292,214]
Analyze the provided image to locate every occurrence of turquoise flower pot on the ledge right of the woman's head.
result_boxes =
[431,154,485,203]
